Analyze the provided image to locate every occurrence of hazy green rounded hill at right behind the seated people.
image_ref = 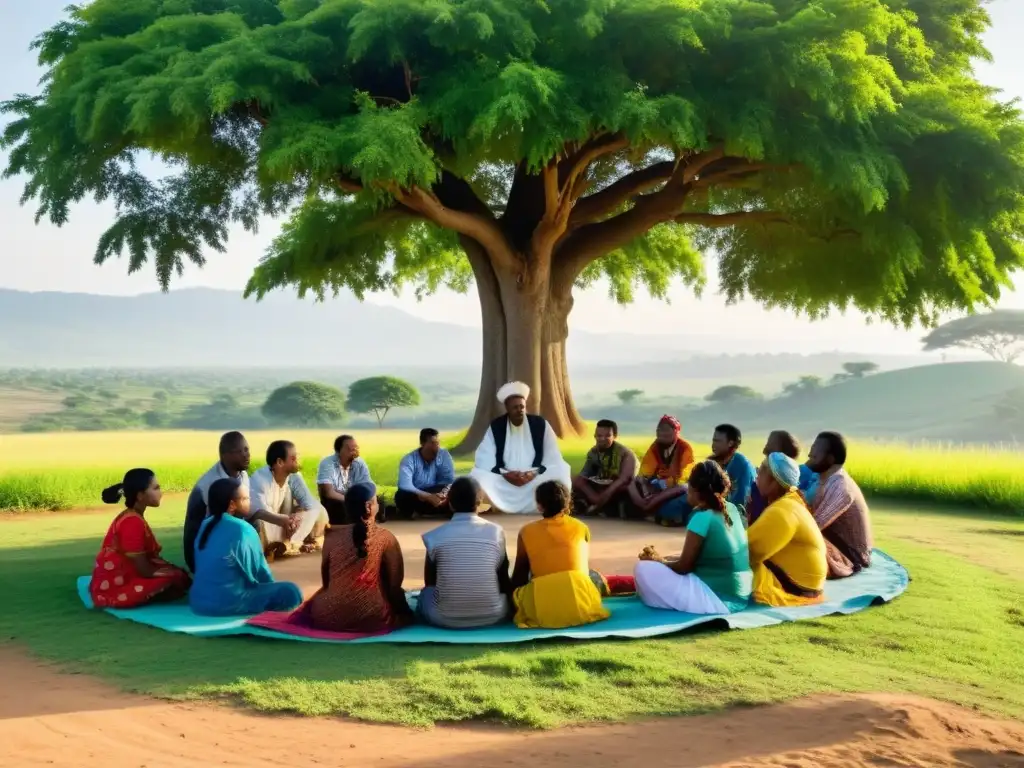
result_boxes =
[671,362,1024,442]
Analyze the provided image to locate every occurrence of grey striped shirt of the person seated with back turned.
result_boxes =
[423,512,508,629]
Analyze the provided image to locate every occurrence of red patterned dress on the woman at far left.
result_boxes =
[89,509,191,608]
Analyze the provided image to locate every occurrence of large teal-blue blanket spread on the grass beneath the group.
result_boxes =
[78,550,910,645]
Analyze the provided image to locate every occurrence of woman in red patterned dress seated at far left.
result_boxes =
[89,469,191,608]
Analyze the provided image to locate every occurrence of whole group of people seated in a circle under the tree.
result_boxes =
[90,382,871,633]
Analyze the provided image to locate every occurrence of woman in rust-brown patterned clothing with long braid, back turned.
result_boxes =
[306,482,413,633]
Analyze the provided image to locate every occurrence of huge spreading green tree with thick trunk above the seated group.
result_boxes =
[3,0,1024,450]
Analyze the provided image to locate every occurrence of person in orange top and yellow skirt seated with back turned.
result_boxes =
[512,480,609,630]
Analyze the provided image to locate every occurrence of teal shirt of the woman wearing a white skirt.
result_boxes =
[686,503,754,612]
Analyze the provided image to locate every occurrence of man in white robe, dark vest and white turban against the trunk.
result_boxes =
[470,381,572,515]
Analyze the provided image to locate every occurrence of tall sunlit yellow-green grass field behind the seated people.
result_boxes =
[0,430,1024,515]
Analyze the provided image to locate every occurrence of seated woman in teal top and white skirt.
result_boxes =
[634,459,754,613]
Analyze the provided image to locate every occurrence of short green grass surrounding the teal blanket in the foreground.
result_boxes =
[0,500,1024,727]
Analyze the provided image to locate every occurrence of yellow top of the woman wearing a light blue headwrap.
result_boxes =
[748,492,828,592]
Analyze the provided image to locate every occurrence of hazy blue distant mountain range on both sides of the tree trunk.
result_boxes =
[0,289,928,387]
